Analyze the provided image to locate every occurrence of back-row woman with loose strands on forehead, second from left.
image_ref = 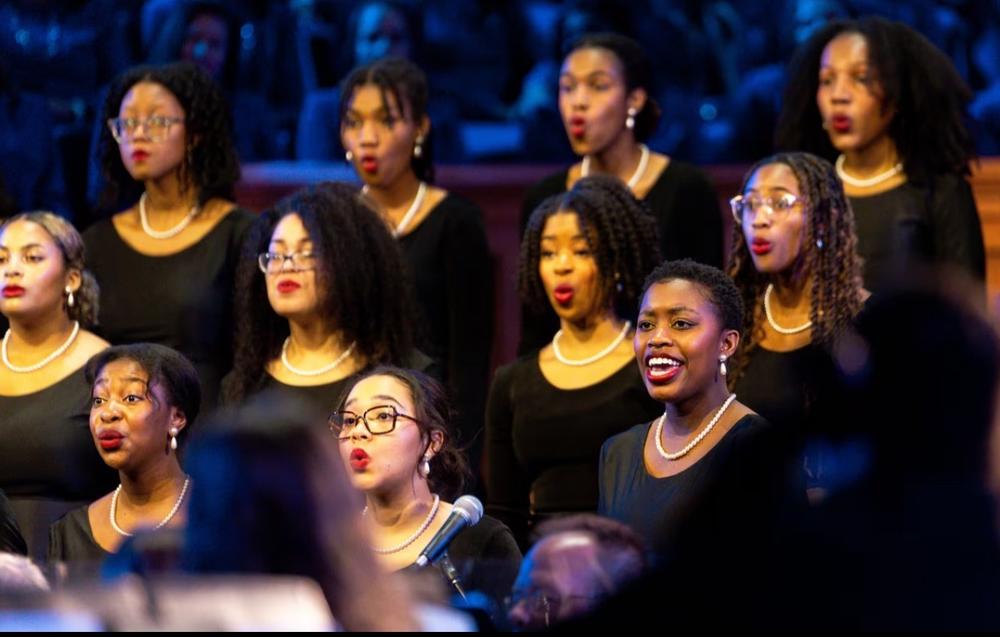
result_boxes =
[340,58,493,482]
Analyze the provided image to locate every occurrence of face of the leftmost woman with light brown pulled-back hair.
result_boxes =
[0,219,80,319]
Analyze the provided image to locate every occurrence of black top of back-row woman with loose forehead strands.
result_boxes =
[399,194,493,466]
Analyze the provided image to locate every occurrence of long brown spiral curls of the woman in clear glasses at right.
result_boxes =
[728,153,862,384]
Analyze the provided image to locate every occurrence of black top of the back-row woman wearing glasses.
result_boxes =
[83,209,254,411]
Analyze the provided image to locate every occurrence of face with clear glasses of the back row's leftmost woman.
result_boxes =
[118,82,187,181]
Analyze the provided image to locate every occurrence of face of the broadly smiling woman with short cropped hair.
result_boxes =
[633,279,739,403]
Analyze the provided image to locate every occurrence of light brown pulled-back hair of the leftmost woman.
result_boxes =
[0,210,101,328]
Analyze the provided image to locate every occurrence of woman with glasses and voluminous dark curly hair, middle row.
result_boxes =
[224,183,432,412]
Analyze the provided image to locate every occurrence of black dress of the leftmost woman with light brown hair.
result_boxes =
[0,368,118,559]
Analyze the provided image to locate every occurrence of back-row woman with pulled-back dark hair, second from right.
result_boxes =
[518,33,723,354]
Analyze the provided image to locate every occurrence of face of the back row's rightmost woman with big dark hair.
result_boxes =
[816,33,895,153]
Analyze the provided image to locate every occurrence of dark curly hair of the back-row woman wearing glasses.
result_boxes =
[97,62,240,210]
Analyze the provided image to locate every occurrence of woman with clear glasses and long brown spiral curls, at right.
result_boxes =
[729,153,869,495]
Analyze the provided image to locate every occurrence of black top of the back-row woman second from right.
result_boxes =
[518,159,724,354]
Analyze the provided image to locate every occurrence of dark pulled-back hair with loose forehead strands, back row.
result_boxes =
[340,57,434,183]
